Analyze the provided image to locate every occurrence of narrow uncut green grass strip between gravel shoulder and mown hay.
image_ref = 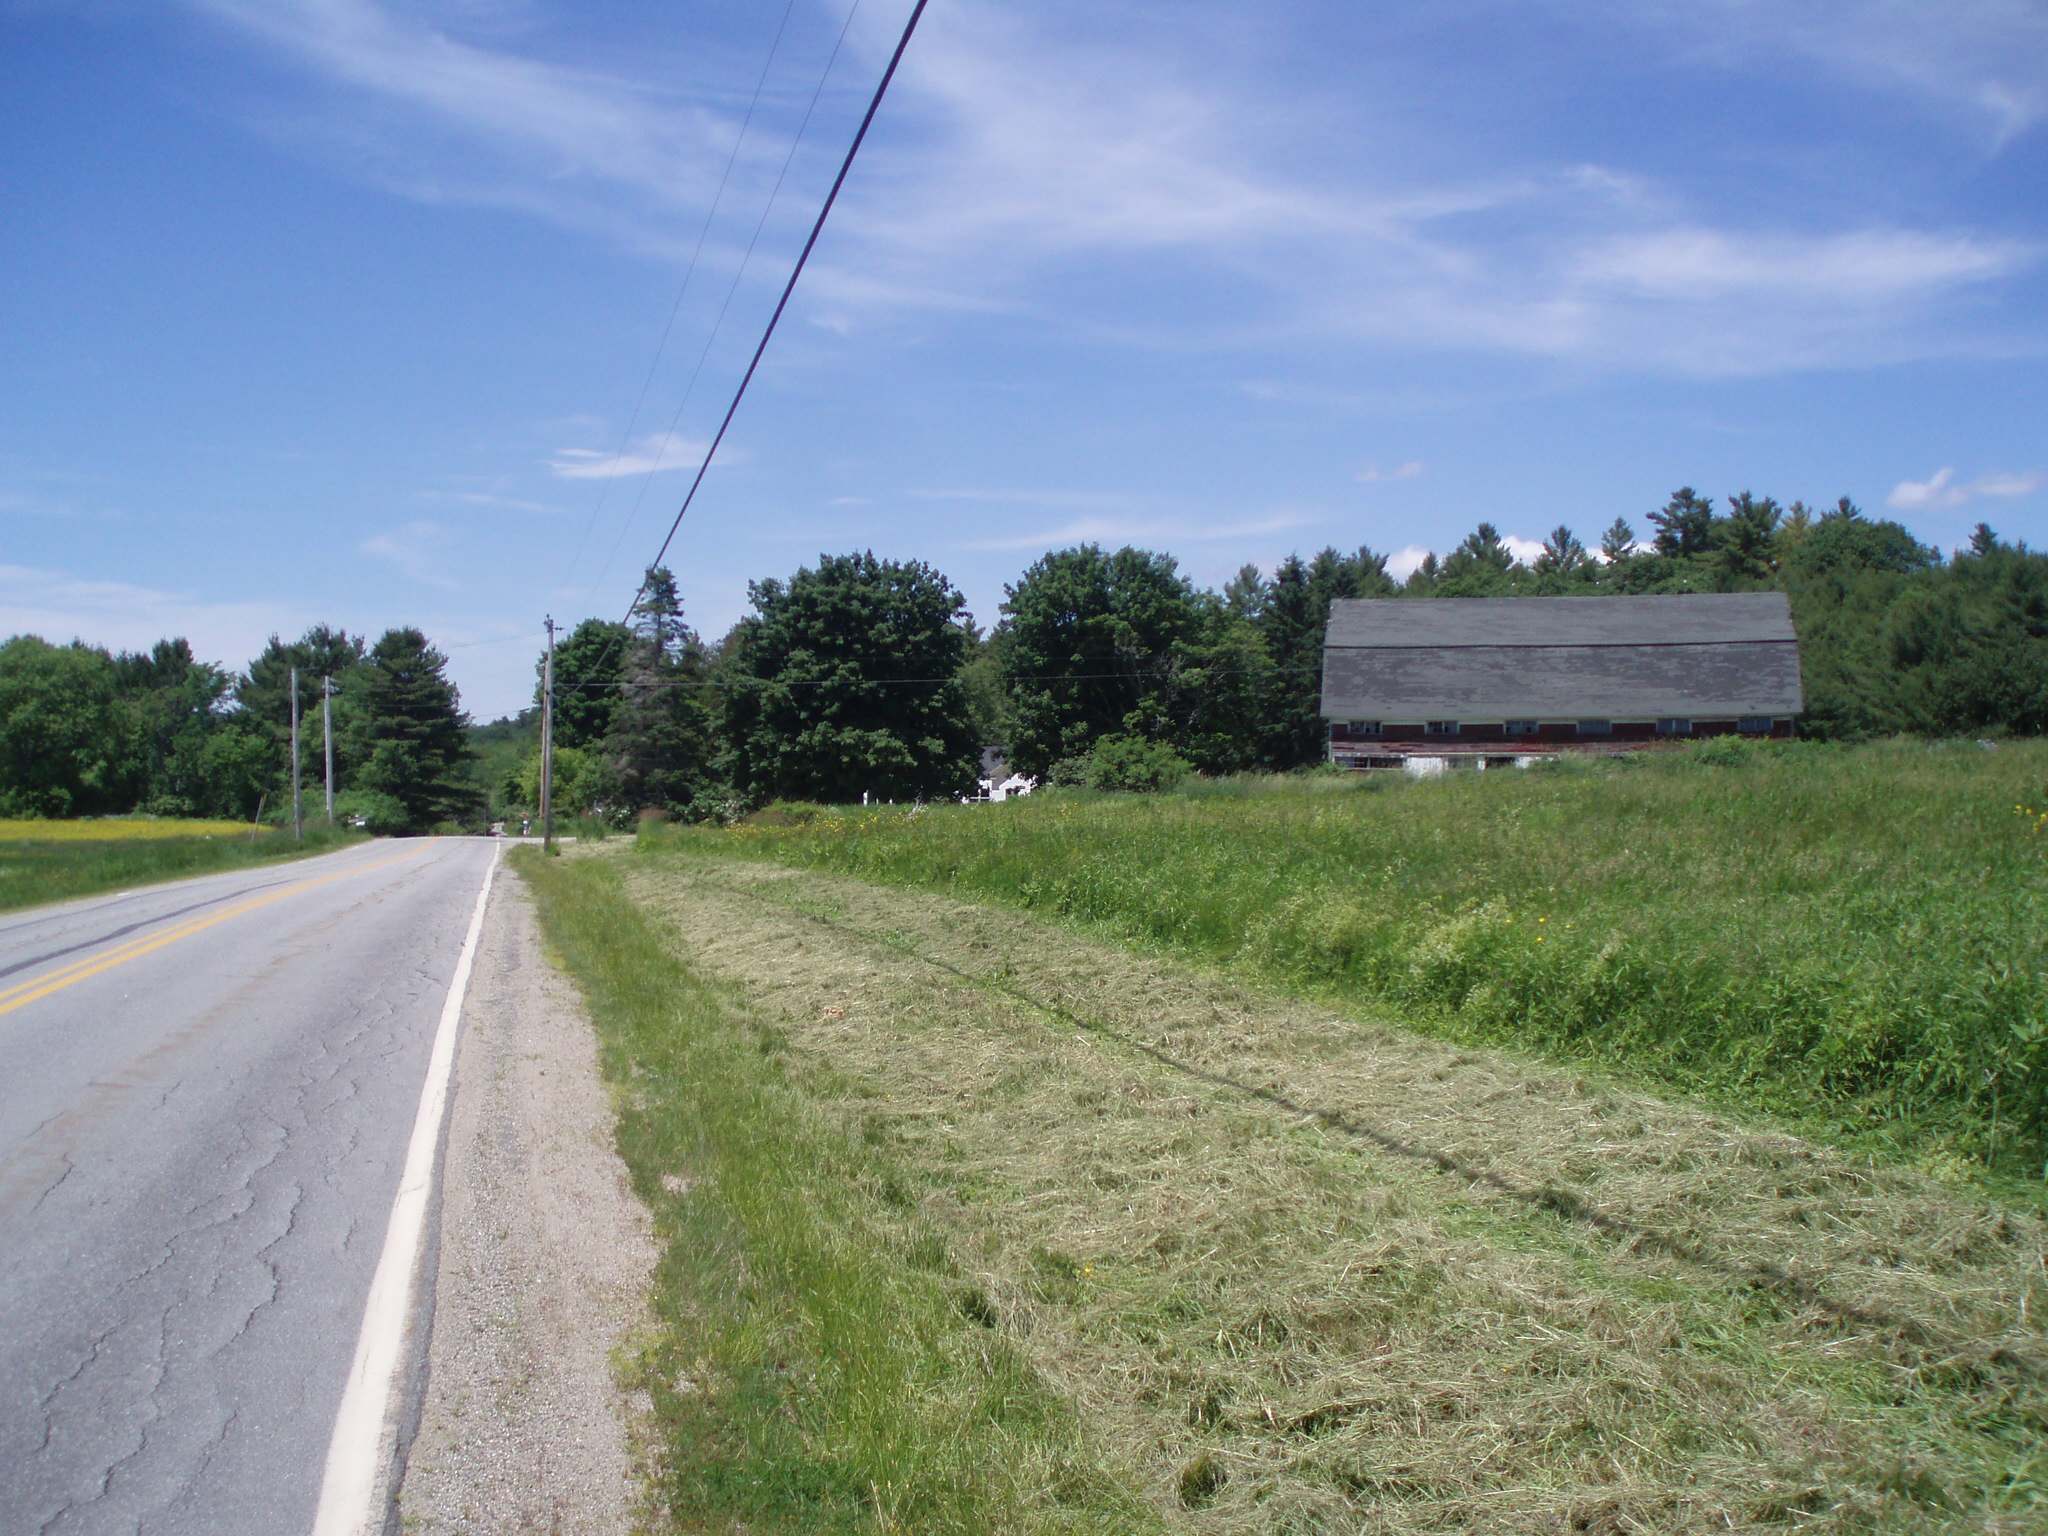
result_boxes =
[512,848,1153,1536]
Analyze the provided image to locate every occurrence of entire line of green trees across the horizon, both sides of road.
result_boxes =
[0,487,2048,831]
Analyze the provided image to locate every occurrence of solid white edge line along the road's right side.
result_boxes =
[313,848,500,1536]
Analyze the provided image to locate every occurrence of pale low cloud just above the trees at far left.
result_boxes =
[0,565,311,668]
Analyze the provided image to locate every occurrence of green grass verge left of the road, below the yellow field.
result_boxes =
[0,821,362,911]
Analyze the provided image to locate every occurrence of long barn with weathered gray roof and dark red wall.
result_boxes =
[1323,592,1804,768]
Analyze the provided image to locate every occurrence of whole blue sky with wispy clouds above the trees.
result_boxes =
[0,0,2048,717]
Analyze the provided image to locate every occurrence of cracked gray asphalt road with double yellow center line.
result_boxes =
[0,838,494,1536]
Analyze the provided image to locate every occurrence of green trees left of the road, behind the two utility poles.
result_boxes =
[0,625,483,831]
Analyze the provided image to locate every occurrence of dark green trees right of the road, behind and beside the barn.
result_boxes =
[502,499,2048,819]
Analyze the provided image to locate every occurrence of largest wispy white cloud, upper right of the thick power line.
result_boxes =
[821,0,2042,375]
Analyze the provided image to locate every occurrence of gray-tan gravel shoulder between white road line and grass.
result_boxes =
[399,870,655,1536]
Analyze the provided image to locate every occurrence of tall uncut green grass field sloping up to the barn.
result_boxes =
[651,741,2048,1180]
